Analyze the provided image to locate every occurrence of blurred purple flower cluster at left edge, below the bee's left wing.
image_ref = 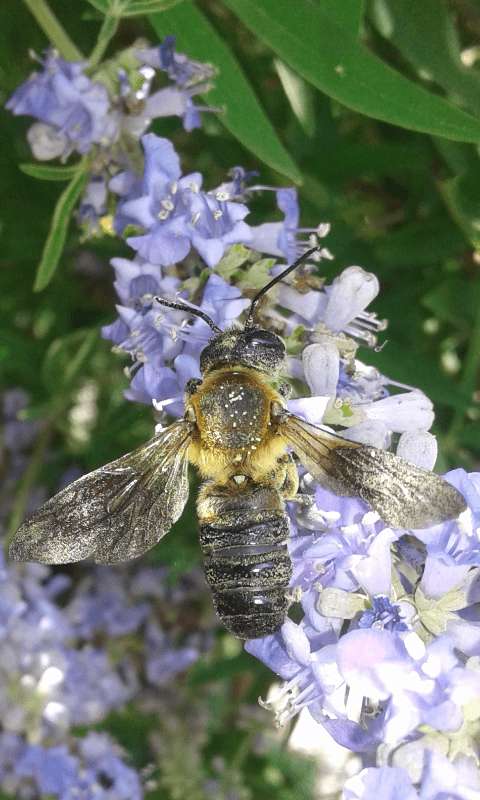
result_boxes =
[0,544,137,741]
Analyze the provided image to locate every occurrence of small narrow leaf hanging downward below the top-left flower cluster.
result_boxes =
[33,157,90,292]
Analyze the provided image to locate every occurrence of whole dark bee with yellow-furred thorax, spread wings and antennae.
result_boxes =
[10,248,466,639]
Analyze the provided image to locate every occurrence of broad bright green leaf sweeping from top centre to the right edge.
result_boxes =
[220,0,480,142]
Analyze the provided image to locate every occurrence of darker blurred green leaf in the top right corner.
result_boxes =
[372,0,480,119]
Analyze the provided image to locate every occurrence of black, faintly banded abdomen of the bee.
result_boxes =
[199,508,292,639]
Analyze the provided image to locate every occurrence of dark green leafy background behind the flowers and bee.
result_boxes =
[0,0,480,800]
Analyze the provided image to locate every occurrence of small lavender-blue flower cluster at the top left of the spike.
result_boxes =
[5,36,215,161]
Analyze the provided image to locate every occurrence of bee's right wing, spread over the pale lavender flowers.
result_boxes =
[279,414,467,528]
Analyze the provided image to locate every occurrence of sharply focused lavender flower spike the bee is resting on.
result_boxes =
[98,134,480,798]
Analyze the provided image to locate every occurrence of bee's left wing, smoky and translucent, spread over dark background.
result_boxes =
[10,419,192,564]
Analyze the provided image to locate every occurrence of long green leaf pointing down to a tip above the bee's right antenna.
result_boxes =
[150,0,301,183]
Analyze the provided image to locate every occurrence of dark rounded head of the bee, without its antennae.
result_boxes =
[200,326,286,375]
